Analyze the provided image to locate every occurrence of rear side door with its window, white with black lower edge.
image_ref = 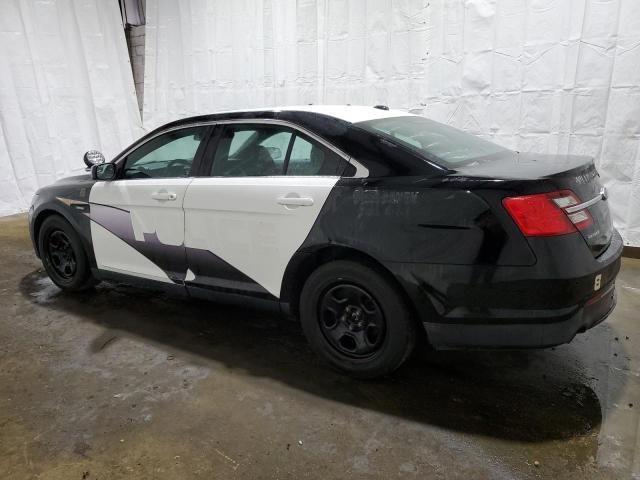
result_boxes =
[184,123,348,298]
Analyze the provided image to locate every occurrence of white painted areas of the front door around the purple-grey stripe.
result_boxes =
[89,178,192,277]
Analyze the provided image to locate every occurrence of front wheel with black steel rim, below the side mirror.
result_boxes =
[38,215,97,292]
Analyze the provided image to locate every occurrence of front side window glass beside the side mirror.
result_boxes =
[123,127,207,179]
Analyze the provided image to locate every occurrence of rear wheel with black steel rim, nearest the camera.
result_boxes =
[300,260,417,378]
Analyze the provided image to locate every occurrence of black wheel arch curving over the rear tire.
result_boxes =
[281,245,422,330]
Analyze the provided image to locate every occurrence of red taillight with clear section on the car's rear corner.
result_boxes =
[502,190,593,237]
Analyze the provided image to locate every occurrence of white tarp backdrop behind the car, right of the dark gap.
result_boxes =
[143,0,640,246]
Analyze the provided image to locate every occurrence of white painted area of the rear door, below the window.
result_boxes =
[183,176,339,297]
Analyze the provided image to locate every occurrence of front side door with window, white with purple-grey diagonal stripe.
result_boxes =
[89,126,211,283]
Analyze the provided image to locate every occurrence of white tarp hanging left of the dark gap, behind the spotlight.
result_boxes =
[0,0,142,215]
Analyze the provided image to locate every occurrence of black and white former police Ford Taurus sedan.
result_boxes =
[30,106,622,377]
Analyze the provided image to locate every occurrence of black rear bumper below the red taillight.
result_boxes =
[387,232,623,349]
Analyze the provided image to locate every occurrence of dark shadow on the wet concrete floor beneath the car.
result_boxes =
[20,271,624,452]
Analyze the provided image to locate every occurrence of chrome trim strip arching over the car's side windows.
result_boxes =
[112,118,369,178]
